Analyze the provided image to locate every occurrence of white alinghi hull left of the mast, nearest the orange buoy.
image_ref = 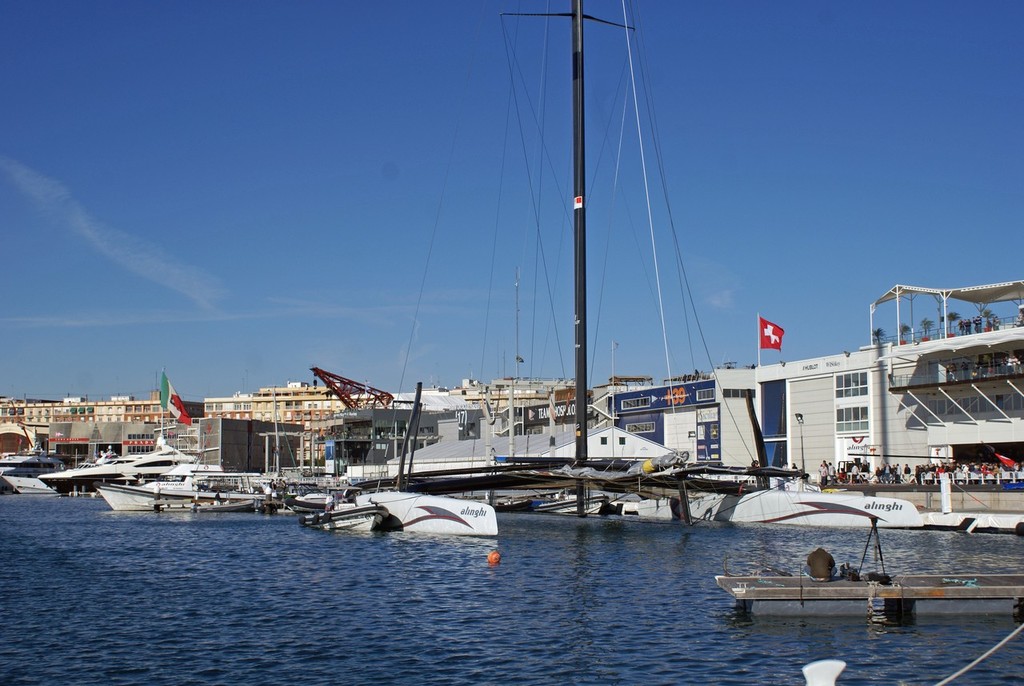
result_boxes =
[355,490,498,535]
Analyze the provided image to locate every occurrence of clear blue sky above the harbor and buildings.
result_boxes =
[0,0,1024,399]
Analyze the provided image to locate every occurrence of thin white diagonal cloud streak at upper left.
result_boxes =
[0,156,225,310]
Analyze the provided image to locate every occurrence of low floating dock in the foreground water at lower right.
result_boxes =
[715,574,1024,617]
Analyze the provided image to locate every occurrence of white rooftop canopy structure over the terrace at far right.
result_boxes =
[869,281,1024,343]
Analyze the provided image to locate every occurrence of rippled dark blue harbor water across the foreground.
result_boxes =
[0,496,1024,686]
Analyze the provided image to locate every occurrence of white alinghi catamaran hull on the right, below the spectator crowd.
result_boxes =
[689,489,925,528]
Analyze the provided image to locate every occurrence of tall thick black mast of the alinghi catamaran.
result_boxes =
[572,0,587,517]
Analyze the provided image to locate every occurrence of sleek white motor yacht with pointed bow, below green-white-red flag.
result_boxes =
[39,442,197,495]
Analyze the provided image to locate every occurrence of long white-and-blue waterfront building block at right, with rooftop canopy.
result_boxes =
[606,282,1024,473]
